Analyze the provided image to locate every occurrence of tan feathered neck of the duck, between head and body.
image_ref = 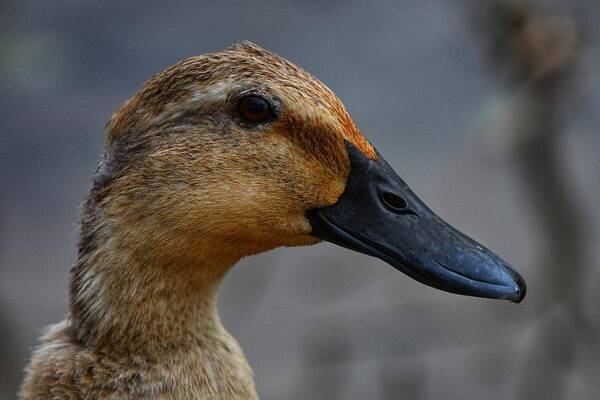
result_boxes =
[71,219,239,356]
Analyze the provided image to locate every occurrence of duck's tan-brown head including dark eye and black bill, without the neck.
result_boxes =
[104,43,525,302]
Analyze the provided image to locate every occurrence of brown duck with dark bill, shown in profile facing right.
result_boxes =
[19,42,526,400]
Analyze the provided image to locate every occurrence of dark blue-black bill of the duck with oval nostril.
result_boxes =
[307,141,526,303]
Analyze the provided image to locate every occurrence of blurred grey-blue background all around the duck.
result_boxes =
[0,0,600,400]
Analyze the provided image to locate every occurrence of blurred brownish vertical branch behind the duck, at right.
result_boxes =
[486,1,585,400]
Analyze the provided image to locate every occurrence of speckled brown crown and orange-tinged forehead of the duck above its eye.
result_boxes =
[108,42,377,160]
